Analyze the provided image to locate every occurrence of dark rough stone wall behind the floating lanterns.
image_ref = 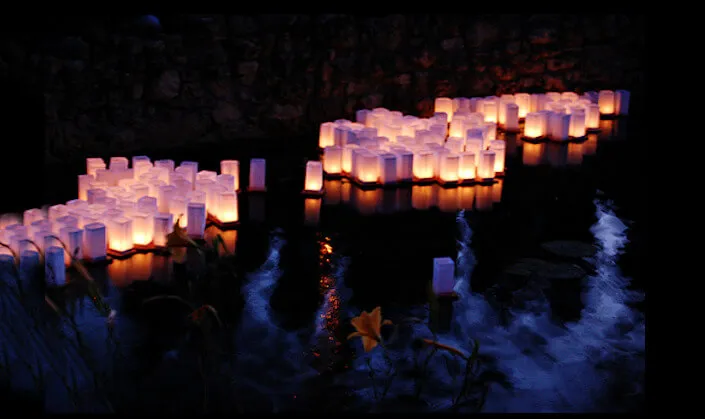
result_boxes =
[0,14,645,158]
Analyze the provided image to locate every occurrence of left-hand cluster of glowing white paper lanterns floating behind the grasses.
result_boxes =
[0,156,266,282]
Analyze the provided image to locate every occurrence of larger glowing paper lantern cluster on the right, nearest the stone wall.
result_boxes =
[306,90,629,192]
